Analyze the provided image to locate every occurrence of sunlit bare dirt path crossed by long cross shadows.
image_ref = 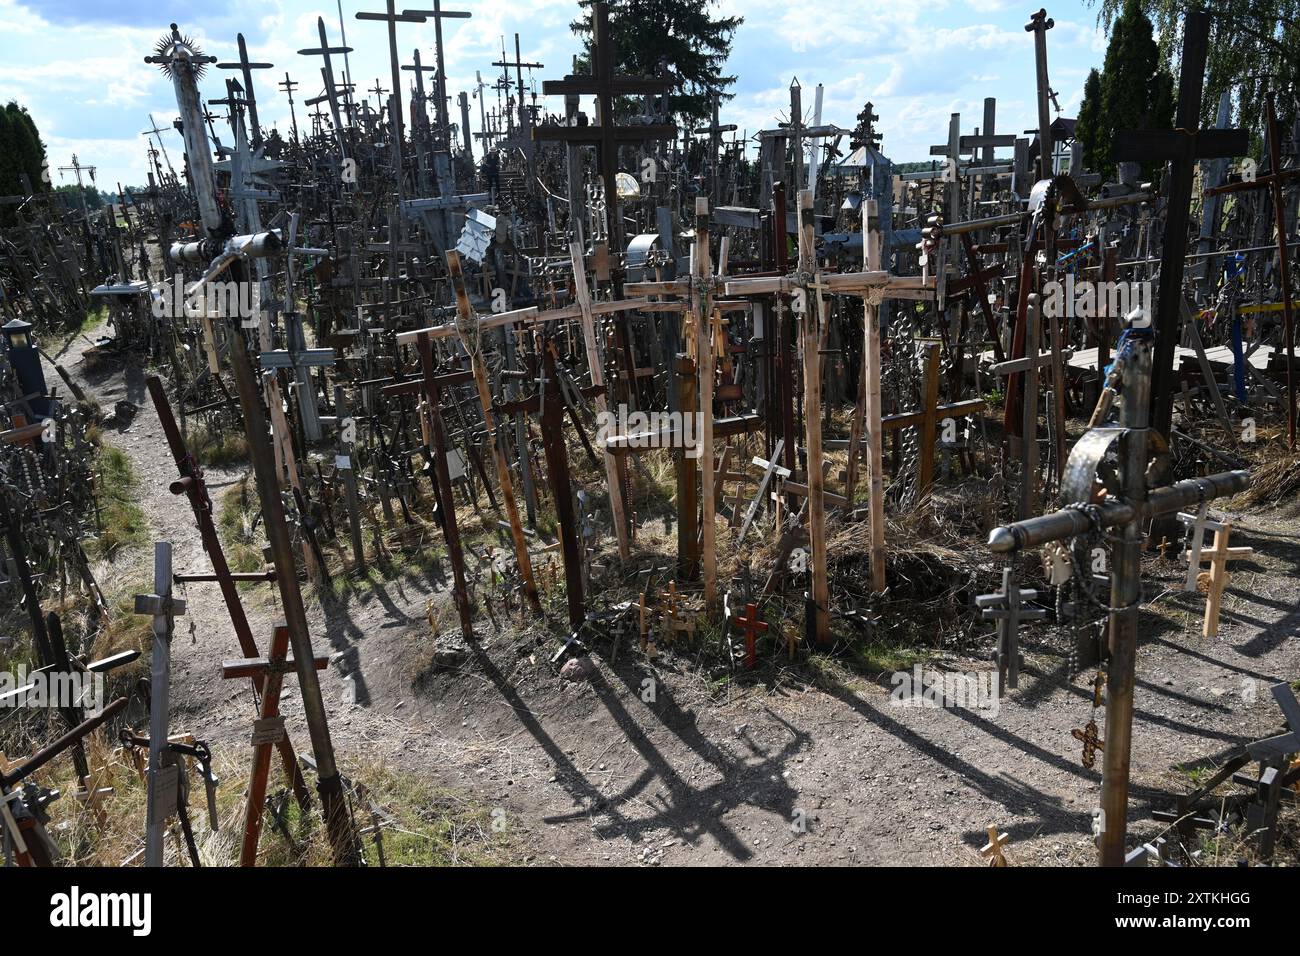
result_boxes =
[48,327,1300,865]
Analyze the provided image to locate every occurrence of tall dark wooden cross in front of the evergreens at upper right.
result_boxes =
[1114,10,1249,436]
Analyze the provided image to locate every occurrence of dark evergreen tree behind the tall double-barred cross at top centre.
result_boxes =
[569,0,744,126]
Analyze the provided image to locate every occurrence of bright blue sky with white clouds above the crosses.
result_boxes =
[0,0,1105,190]
